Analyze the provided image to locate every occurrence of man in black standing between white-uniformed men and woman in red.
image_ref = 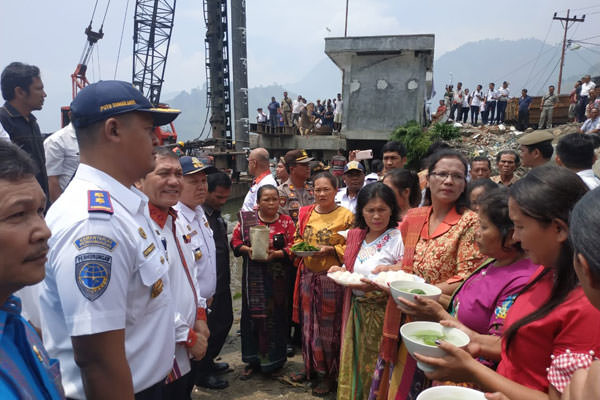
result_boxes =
[196,172,233,389]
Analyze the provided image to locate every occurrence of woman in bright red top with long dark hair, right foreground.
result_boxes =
[415,166,600,400]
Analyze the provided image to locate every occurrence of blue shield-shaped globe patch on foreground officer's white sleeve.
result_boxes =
[75,253,112,301]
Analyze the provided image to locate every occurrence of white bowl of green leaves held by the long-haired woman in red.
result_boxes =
[400,321,470,372]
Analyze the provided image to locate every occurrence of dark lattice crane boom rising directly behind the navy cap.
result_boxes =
[132,0,177,145]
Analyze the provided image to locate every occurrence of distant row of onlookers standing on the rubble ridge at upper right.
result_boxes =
[432,75,600,131]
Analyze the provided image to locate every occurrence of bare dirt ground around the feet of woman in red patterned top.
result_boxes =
[192,248,335,400]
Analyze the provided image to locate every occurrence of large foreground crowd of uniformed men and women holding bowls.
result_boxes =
[0,57,600,400]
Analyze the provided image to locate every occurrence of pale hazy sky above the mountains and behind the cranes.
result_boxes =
[0,0,600,132]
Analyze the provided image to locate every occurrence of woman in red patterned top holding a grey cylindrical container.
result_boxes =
[231,185,295,380]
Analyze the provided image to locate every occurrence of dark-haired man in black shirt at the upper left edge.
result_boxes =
[0,62,50,198]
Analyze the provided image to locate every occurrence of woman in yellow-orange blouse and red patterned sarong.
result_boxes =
[292,172,354,396]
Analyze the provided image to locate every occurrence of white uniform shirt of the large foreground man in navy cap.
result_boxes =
[40,164,175,399]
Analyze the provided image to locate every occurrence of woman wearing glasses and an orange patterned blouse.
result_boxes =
[370,150,483,399]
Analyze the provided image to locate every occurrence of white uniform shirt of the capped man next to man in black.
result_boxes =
[174,202,217,299]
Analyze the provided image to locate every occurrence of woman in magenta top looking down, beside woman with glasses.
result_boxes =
[399,187,539,365]
